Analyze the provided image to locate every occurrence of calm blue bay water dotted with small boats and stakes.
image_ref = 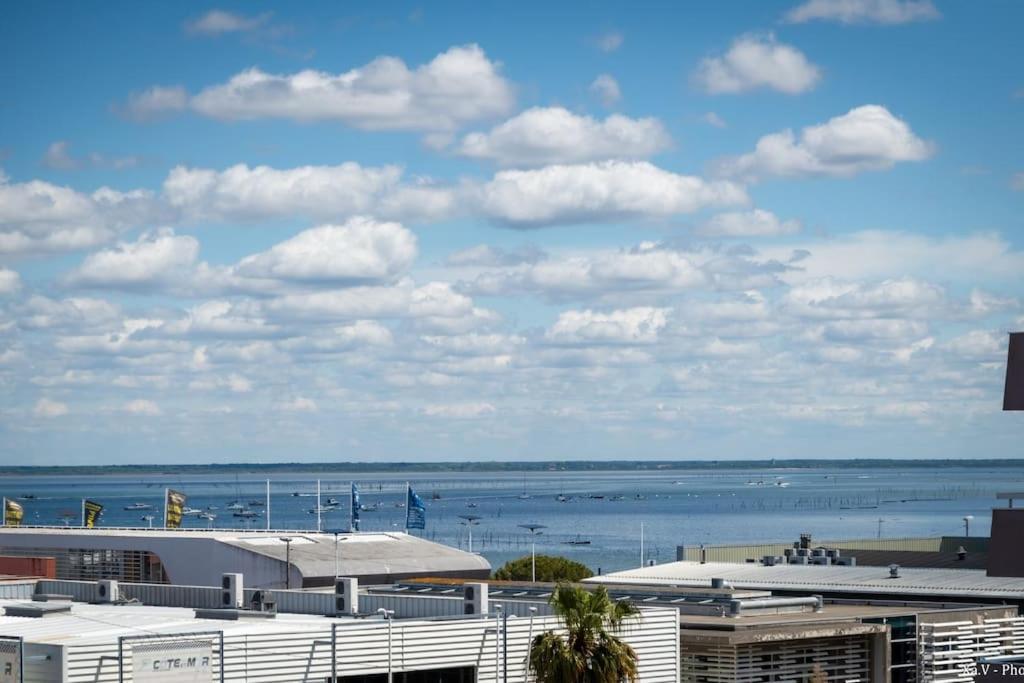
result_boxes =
[0,468,1024,572]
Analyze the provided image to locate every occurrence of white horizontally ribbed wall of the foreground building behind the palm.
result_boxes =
[59,608,679,683]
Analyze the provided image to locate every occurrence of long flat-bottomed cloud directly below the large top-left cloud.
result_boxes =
[163,162,455,221]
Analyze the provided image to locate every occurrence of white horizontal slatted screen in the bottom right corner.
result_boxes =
[920,616,1024,683]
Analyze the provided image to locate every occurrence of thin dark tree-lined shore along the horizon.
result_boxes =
[0,459,1024,475]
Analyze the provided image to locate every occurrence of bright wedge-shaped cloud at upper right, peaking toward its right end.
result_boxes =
[720,104,935,179]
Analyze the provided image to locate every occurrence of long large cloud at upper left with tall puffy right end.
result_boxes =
[126,45,515,131]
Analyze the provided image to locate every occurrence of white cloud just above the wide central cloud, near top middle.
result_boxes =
[458,106,672,167]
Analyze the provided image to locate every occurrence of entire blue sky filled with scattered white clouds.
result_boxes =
[0,0,1024,465]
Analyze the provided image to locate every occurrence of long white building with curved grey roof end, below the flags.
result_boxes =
[0,526,490,588]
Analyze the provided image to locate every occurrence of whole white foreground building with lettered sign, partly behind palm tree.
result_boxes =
[0,582,679,683]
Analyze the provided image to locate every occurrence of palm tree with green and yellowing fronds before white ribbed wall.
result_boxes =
[529,585,638,683]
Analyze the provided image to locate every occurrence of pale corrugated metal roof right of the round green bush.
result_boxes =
[587,562,1024,600]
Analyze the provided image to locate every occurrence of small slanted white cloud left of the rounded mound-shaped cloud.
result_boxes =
[68,228,199,289]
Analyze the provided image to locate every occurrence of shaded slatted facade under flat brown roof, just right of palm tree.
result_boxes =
[680,636,870,683]
